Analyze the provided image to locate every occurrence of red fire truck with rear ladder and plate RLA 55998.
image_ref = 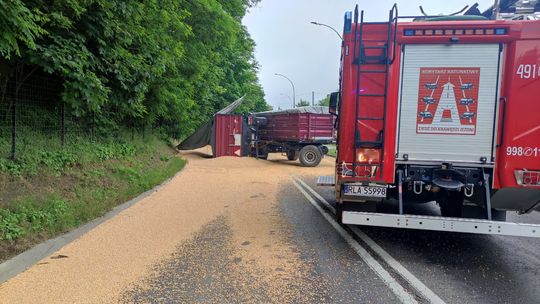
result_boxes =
[318,5,540,237]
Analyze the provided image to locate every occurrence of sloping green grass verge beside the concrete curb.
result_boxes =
[0,135,185,262]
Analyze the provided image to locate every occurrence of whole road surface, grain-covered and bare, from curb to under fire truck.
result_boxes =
[0,151,540,304]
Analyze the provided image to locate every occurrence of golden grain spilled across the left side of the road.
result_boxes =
[0,149,333,303]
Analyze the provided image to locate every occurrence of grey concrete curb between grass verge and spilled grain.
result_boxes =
[0,163,188,284]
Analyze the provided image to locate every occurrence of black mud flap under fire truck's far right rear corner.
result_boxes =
[491,188,540,213]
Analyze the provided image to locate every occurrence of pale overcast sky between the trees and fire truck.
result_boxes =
[244,0,494,109]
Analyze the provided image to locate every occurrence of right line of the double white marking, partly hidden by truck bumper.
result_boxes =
[293,177,445,304]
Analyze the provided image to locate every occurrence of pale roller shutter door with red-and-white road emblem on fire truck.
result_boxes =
[396,44,501,163]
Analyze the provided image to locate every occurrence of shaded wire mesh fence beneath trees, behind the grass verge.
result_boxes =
[0,67,173,165]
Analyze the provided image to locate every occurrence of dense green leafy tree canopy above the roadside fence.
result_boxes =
[0,0,268,138]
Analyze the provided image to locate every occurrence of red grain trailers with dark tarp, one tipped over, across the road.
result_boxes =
[177,99,335,167]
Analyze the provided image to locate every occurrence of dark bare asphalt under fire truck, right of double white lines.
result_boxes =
[305,177,540,303]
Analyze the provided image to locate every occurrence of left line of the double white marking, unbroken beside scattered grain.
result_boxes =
[293,180,418,303]
